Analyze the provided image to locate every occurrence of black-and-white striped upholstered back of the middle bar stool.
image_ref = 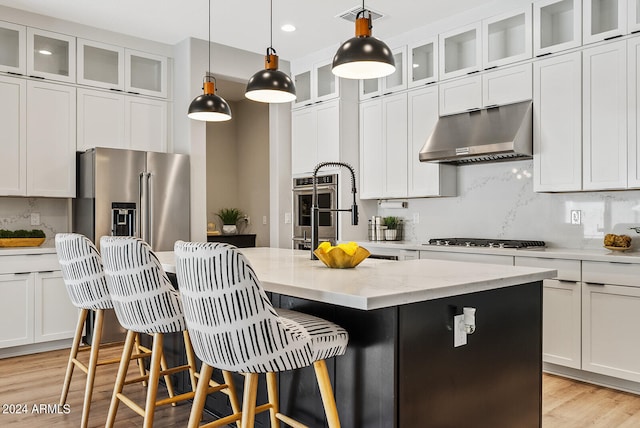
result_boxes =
[100,236,186,334]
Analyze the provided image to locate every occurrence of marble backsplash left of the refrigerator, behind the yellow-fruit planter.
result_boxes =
[0,197,71,247]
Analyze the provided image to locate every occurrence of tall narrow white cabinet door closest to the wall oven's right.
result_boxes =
[359,99,384,199]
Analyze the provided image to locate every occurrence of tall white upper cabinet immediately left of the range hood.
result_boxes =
[407,86,457,198]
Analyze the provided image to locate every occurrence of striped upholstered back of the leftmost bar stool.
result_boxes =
[55,233,113,310]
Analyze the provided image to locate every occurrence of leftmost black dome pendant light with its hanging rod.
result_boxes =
[187,0,231,122]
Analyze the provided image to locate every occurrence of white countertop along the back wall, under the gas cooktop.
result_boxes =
[358,241,640,263]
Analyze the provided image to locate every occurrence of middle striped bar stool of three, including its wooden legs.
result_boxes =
[100,236,240,427]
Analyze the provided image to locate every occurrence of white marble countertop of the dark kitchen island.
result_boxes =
[156,248,556,310]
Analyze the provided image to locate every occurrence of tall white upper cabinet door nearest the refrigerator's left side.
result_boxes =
[27,81,76,198]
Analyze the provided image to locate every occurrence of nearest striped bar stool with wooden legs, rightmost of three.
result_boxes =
[175,241,349,428]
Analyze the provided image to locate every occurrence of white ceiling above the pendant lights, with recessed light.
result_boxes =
[0,0,493,60]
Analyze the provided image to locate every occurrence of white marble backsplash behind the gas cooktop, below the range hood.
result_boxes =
[378,160,640,249]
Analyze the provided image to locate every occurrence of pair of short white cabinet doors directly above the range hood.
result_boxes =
[439,64,532,116]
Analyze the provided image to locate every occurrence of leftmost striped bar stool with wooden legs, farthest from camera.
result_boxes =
[55,233,150,428]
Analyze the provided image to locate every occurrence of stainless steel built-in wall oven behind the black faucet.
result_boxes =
[293,174,338,250]
